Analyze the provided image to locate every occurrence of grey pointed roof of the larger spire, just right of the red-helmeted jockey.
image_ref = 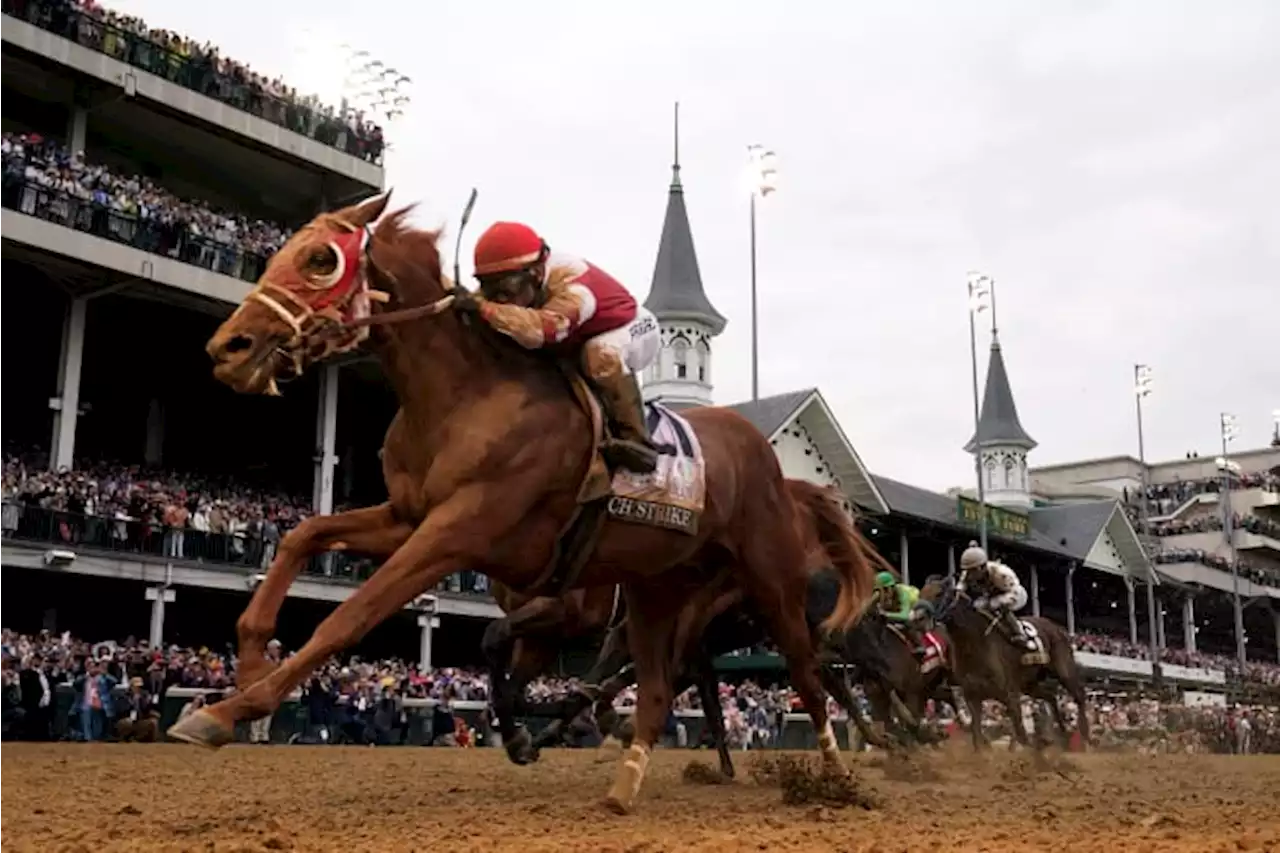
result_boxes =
[644,104,726,334]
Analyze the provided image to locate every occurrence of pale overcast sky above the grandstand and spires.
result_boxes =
[111,0,1280,488]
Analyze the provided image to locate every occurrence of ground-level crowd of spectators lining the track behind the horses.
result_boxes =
[0,629,1280,753]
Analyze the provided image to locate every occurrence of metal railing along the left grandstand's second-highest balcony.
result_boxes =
[0,174,268,282]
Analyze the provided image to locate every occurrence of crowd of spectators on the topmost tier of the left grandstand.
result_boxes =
[0,0,385,164]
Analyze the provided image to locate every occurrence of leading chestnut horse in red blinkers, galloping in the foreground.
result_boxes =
[169,195,873,812]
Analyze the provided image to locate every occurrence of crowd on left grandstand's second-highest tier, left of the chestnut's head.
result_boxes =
[0,133,288,280]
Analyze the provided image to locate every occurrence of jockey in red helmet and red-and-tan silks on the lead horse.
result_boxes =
[454,222,662,474]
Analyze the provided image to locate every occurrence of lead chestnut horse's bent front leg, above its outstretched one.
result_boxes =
[236,503,413,690]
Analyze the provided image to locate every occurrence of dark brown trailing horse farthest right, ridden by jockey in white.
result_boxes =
[922,576,1089,748]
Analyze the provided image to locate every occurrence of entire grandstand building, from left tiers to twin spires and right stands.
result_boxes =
[0,0,1280,712]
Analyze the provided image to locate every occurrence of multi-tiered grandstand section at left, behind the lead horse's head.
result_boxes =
[0,0,495,660]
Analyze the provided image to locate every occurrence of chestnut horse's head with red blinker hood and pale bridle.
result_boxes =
[205,193,448,394]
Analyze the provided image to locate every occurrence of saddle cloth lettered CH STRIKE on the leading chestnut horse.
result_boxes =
[605,403,707,535]
